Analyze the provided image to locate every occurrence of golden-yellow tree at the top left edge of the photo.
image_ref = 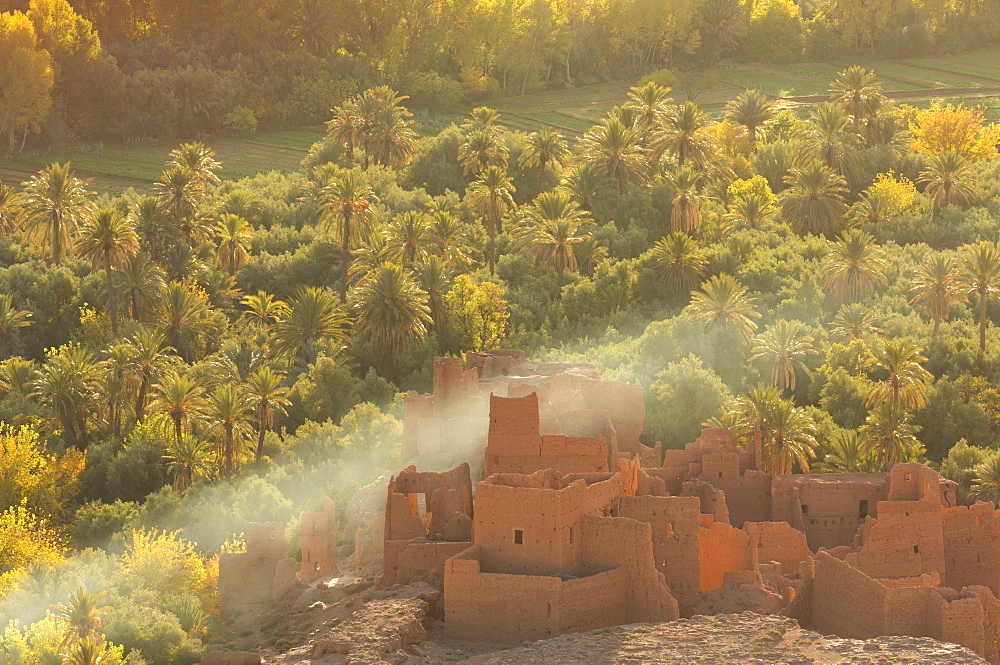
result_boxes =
[0,12,53,152]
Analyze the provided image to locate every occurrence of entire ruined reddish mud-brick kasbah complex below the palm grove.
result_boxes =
[219,351,1000,663]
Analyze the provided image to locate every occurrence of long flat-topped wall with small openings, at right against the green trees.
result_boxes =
[771,473,889,550]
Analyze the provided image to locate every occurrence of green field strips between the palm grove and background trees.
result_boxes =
[0,48,1000,191]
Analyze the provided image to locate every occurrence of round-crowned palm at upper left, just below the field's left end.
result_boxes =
[20,162,92,263]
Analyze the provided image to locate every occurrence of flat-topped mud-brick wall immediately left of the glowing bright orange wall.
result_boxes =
[618,496,701,607]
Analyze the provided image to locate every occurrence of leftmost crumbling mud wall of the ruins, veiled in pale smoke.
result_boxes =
[219,522,299,618]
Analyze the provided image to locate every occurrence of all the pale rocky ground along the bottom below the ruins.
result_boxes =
[205,577,986,665]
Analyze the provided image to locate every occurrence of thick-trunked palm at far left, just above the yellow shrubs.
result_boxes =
[31,345,99,450]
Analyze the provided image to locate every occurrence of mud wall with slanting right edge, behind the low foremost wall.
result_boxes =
[580,515,680,623]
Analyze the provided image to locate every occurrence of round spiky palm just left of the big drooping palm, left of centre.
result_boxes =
[274,286,350,364]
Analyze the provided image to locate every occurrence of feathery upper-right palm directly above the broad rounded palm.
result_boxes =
[795,102,864,184]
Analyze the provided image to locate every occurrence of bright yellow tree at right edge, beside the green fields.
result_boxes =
[904,102,1000,161]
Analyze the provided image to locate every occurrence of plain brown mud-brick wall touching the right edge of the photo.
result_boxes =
[941,501,1000,594]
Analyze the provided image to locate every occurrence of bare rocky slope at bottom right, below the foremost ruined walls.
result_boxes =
[452,612,986,665]
